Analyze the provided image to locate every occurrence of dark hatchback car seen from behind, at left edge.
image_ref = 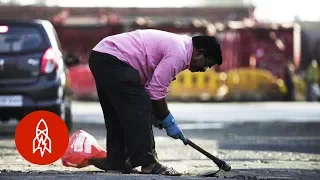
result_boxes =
[0,20,77,129]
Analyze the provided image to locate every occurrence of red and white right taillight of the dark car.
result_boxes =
[40,48,58,74]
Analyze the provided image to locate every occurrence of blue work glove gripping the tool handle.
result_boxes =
[161,113,187,145]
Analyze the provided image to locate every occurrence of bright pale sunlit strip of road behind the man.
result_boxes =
[73,102,320,123]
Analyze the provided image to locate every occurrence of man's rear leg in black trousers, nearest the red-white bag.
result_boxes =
[89,52,125,170]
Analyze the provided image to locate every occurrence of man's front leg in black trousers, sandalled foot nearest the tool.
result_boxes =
[89,51,180,175]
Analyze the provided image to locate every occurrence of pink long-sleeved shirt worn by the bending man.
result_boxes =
[93,29,193,100]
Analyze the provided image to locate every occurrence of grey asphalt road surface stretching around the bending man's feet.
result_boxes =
[0,102,320,180]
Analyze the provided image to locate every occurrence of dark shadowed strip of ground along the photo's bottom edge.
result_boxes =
[1,169,320,180]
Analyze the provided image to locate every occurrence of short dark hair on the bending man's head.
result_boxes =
[192,36,222,65]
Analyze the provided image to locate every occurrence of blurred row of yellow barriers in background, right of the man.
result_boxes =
[168,68,305,100]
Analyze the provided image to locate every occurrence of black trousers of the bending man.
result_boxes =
[89,51,158,170]
